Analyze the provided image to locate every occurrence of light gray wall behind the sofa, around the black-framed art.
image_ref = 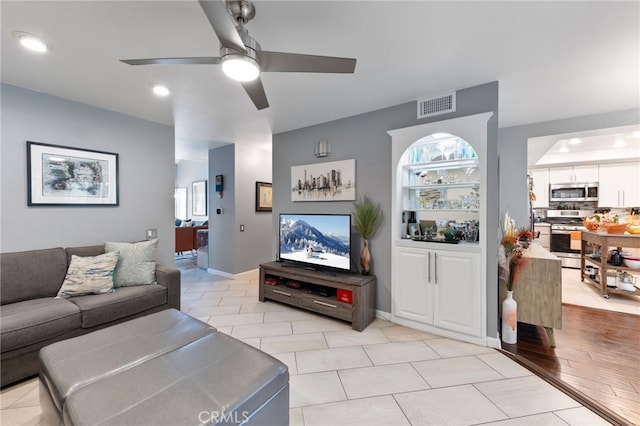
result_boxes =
[0,84,175,265]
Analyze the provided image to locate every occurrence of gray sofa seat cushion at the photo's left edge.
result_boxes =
[0,298,81,352]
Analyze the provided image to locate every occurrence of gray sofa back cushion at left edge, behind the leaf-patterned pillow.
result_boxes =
[0,247,67,305]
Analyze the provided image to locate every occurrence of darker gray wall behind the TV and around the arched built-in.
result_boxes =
[272,82,498,322]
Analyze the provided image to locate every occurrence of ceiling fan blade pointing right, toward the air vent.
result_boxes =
[258,50,356,73]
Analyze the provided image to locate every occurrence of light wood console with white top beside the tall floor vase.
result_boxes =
[498,243,562,347]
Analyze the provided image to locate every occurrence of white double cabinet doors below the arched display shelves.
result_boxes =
[392,247,482,337]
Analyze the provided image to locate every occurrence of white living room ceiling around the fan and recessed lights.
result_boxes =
[1,0,640,159]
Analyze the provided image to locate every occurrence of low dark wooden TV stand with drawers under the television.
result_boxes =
[258,262,376,331]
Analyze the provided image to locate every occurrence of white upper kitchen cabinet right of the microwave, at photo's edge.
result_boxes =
[598,161,640,207]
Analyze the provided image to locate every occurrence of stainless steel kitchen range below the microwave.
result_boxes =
[547,210,594,269]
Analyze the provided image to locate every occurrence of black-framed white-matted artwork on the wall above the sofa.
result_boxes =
[27,141,120,207]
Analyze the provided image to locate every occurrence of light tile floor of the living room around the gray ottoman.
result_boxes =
[0,269,608,426]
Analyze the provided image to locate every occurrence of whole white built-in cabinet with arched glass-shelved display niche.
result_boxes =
[388,113,492,346]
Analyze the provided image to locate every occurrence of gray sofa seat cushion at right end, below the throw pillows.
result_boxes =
[68,284,167,328]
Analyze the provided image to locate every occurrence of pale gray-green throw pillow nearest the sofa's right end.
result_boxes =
[104,238,158,287]
